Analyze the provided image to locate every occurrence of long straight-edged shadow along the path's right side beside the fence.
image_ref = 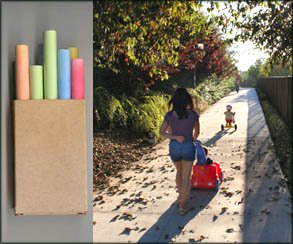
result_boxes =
[242,89,292,243]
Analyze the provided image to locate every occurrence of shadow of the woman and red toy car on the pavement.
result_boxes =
[138,189,217,243]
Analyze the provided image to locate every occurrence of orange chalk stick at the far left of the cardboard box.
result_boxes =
[15,44,30,100]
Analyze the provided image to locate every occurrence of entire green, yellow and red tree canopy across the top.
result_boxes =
[94,0,292,93]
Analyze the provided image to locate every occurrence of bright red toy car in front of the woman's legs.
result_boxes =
[191,162,224,190]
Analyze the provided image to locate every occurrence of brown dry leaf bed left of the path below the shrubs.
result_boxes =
[93,131,153,191]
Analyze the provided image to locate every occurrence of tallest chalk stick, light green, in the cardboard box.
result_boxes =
[43,30,58,99]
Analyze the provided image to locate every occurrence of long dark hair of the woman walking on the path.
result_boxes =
[168,87,194,119]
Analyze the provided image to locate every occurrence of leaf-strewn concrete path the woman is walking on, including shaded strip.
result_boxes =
[93,88,292,243]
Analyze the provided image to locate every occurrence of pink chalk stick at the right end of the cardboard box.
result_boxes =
[70,58,84,99]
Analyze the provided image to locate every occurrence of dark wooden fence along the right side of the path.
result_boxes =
[256,76,292,128]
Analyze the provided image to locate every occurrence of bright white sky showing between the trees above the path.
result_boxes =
[203,1,269,71]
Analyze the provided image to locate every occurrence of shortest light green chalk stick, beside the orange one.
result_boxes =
[29,65,43,99]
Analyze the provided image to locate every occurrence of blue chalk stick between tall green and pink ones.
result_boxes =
[58,49,71,99]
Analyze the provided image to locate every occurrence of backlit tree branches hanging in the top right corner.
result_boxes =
[206,1,293,65]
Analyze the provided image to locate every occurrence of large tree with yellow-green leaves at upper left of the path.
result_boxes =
[94,1,210,93]
